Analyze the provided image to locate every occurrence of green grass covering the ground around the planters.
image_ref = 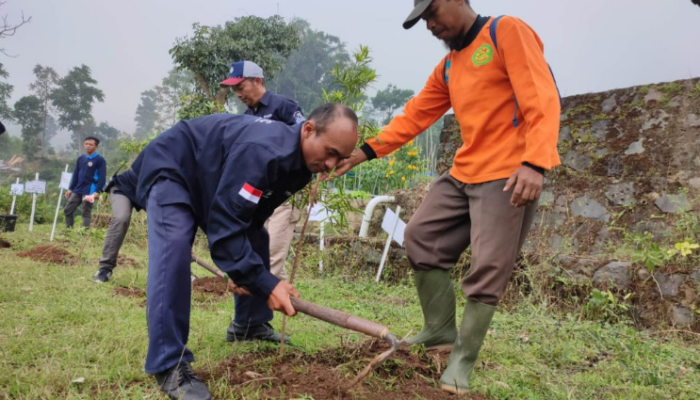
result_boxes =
[0,224,700,400]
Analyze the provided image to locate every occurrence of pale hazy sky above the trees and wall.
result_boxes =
[0,0,700,145]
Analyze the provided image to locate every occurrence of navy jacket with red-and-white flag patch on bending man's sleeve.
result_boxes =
[132,114,311,297]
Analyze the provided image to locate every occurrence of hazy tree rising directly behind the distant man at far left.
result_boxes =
[51,64,104,149]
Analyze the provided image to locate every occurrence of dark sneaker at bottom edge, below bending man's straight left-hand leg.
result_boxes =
[155,361,211,400]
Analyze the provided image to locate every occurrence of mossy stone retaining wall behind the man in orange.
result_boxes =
[404,78,700,329]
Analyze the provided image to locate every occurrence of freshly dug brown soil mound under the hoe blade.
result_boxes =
[199,341,488,400]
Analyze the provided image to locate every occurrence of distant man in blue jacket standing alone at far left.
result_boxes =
[63,136,107,228]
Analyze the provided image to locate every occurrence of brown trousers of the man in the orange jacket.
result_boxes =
[405,173,537,306]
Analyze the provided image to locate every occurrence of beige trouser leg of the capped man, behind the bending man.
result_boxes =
[265,204,301,280]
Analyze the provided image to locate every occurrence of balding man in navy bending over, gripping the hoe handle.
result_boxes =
[132,104,358,400]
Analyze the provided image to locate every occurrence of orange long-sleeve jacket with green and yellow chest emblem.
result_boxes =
[363,17,561,184]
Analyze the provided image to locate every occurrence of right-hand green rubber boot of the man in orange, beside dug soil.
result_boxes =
[440,299,496,394]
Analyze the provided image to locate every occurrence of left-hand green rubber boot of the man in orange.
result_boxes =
[407,269,457,350]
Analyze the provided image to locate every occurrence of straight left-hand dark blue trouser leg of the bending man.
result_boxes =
[145,180,197,374]
